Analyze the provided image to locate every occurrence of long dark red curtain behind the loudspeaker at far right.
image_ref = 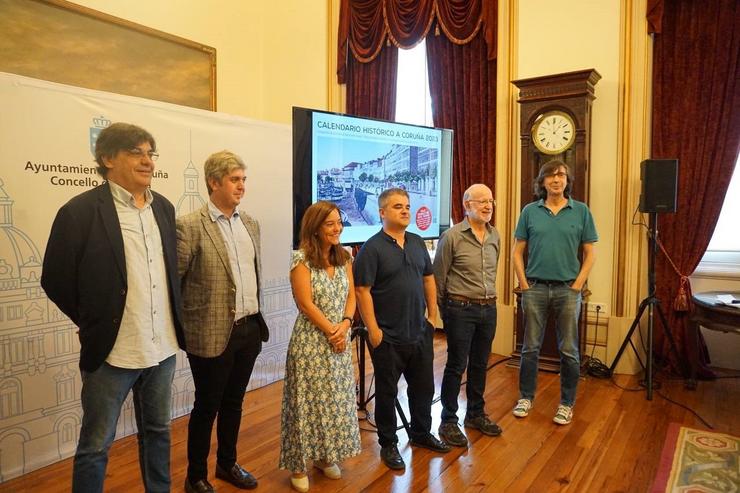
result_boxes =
[651,0,740,378]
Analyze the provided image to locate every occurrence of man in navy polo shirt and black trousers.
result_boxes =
[354,188,450,469]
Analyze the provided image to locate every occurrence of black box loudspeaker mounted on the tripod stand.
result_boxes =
[640,159,678,212]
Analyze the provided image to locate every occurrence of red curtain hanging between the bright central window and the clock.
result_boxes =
[427,26,496,222]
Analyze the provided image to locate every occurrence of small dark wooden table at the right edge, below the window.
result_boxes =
[690,291,740,379]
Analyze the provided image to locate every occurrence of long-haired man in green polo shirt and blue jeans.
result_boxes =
[513,160,599,425]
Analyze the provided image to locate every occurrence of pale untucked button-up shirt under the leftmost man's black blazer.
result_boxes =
[105,181,178,369]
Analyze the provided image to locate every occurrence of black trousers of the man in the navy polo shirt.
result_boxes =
[370,326,434,447]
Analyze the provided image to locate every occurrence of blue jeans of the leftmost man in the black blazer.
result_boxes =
[72,355,175,493]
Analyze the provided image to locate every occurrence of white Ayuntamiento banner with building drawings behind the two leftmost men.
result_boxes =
[0,74,297,480]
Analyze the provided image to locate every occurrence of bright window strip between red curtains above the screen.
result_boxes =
[396,41,434,127]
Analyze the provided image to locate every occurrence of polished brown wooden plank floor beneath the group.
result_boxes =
[0,334,740,493]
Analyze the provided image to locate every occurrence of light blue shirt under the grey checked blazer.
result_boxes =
[208,200,259,320]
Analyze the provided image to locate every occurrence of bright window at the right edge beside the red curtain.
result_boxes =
[696,157,740,277]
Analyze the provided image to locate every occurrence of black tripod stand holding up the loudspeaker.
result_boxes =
[609,212,689,401]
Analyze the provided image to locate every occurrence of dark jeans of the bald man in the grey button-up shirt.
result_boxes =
[441,299,496,423]
